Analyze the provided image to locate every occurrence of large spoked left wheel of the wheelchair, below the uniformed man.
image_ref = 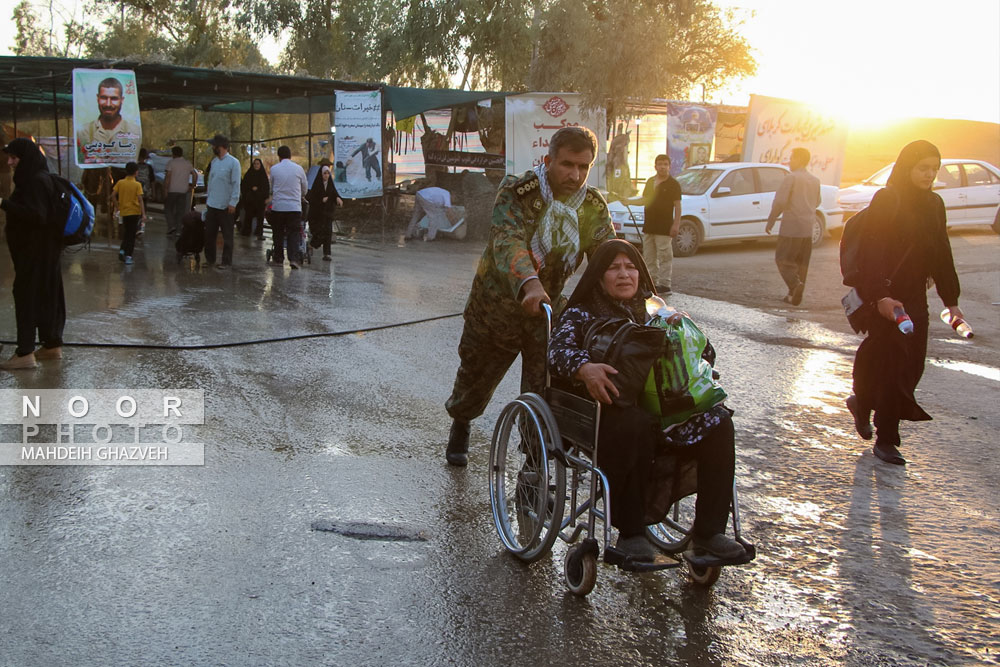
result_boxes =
[489,394,566,563]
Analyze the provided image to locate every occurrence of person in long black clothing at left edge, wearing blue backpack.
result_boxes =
[0,138,66,371]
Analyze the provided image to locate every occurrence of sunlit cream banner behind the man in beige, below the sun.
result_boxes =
[743,95,847,187]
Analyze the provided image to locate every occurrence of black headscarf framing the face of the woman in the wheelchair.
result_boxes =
[567,239,656,323]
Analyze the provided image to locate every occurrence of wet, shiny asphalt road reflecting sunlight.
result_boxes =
[0,223,1000,665]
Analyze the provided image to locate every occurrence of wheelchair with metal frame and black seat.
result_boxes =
[489,304,756,596]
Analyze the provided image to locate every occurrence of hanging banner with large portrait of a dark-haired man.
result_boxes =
[73,69,142,169]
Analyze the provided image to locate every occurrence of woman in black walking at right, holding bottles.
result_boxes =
[847,140,962,465]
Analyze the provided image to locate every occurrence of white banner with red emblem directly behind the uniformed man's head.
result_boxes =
[506,93,607,187]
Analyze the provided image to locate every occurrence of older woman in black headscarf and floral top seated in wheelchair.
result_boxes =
[548,239,746,560]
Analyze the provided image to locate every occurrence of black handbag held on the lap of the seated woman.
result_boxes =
[583,317,665,408]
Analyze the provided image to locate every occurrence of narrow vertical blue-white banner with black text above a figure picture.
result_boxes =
[333,90,383,199]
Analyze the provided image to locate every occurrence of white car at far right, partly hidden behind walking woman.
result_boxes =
[840,159,1000,234]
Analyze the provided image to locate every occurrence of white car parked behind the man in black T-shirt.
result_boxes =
[608,162,844,257]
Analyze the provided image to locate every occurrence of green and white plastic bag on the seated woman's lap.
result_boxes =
[639,316,726,428]
